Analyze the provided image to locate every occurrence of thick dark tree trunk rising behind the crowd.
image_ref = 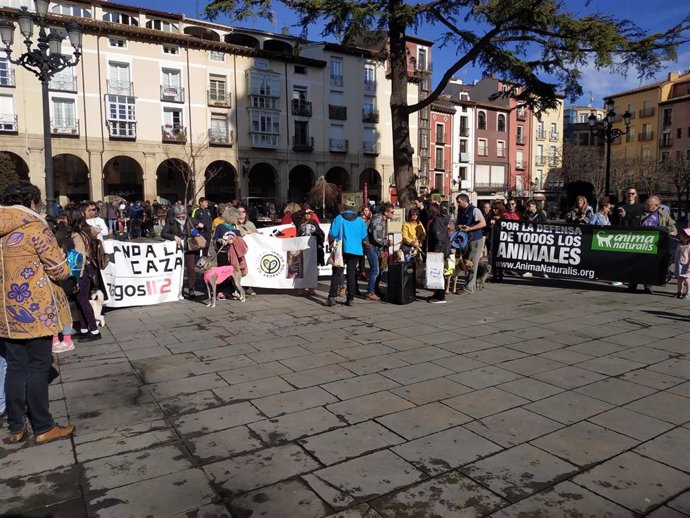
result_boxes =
[388,0,417,208]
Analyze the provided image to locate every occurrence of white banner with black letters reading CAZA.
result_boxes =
[101,239,184,308]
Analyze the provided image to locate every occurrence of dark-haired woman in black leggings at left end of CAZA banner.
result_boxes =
[62,208,101,343]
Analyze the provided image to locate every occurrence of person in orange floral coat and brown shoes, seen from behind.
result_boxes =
[0,181,74,444]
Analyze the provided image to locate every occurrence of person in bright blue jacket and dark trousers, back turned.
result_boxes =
[326,199,367,306]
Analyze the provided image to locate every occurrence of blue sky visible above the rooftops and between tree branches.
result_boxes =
[116,0,690,106]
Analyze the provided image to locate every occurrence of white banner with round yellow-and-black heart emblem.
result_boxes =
[242,234,319,289]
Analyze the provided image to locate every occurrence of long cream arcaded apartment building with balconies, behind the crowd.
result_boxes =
[0,0,430,207]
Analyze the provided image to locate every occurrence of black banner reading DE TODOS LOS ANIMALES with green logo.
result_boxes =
[492,220,670,284]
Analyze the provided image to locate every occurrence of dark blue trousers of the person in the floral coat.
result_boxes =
[2,336,55,435]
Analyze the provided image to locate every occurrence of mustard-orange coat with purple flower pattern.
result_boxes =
[0,205,72,340]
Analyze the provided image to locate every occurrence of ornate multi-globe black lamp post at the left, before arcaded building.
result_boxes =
[0,0,83,216]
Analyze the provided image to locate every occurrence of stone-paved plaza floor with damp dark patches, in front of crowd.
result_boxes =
[0,279,690,518]
